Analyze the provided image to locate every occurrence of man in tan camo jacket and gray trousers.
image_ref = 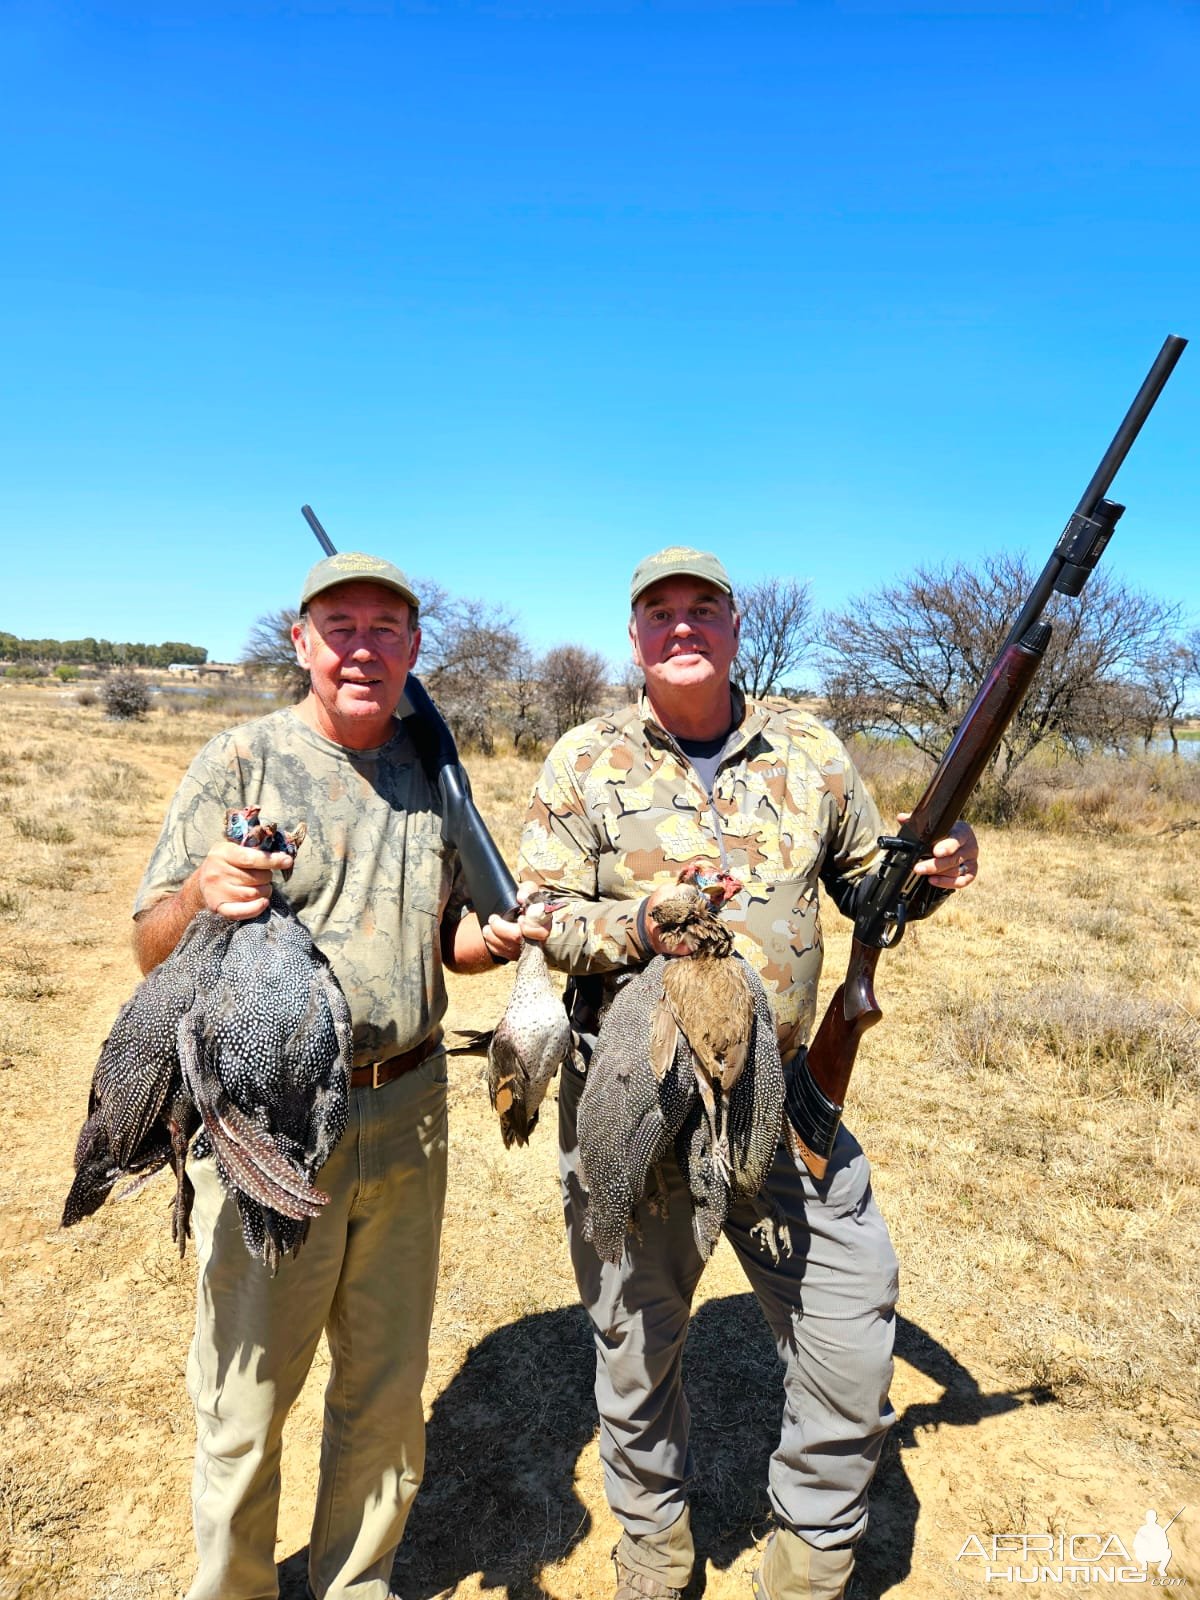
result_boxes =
[518,547,978,1600]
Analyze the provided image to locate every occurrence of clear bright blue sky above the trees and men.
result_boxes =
[0,0,1200,675]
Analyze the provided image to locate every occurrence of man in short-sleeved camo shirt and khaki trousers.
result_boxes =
[134,552,536,1600]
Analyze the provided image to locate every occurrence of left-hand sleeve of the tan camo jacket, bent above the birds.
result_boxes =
[517,730,645,973]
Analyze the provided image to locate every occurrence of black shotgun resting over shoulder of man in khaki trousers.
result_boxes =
[301,506,517,923]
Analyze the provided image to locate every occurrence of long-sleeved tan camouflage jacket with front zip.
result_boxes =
[518,690,902,1059]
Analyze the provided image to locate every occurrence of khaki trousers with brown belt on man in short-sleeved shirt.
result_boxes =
[187,1051,446,1600]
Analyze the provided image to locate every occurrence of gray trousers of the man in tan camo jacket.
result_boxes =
[558,1067,898,1587]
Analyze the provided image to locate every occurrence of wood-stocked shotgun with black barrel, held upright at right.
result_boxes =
[786,334,1187,1179]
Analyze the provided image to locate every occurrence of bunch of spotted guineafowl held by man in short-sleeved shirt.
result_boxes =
[62,806,352,1270]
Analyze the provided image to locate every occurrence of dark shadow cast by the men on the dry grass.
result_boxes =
[280,1294,1053,1600]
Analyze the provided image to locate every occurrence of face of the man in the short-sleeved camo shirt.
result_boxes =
[291,581,421,749]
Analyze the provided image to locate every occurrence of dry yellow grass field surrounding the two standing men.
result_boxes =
[0,690,1200,1600]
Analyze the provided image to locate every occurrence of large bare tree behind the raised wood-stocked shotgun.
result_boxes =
[822,555,1178,787]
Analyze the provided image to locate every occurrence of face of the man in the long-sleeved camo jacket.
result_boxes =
[629,578,741,698]
